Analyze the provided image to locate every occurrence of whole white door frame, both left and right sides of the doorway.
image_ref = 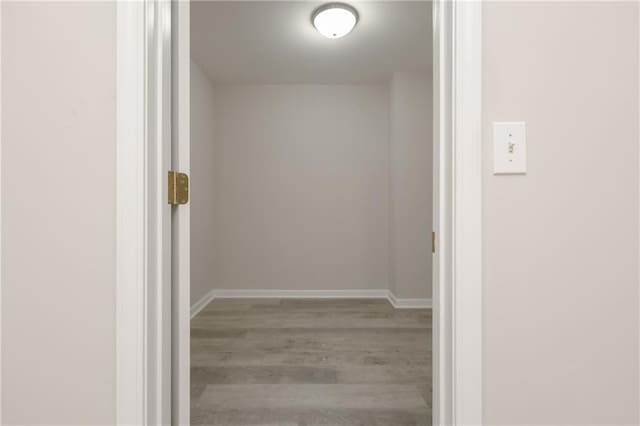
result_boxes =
[116,0,482,425]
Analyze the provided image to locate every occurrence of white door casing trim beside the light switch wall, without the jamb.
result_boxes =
[448,0,482,425]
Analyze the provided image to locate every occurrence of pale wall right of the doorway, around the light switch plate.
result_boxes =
[483,2,640,425]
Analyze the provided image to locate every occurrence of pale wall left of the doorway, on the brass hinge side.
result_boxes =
[0,2,116,425]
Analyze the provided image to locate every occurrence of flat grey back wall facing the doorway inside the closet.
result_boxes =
[210,85,389,290]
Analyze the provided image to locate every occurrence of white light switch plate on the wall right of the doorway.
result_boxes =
[493,121,527,175]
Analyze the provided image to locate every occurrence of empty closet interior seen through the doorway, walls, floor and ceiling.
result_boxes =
[191,1,433,425]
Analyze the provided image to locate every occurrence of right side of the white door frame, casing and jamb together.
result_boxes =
[442,0,483,425]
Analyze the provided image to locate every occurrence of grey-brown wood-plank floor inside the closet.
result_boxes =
[191,299,432,426]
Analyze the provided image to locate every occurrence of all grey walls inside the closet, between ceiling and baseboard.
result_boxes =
[191,78,432,304]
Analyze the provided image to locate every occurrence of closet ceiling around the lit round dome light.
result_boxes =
[191,1,432,84]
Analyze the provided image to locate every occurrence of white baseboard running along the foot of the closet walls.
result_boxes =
[191,289,432,318]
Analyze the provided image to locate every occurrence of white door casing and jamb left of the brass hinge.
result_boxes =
[116,0,171,425]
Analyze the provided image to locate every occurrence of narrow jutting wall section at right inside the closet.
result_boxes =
[389,72,433,298]
